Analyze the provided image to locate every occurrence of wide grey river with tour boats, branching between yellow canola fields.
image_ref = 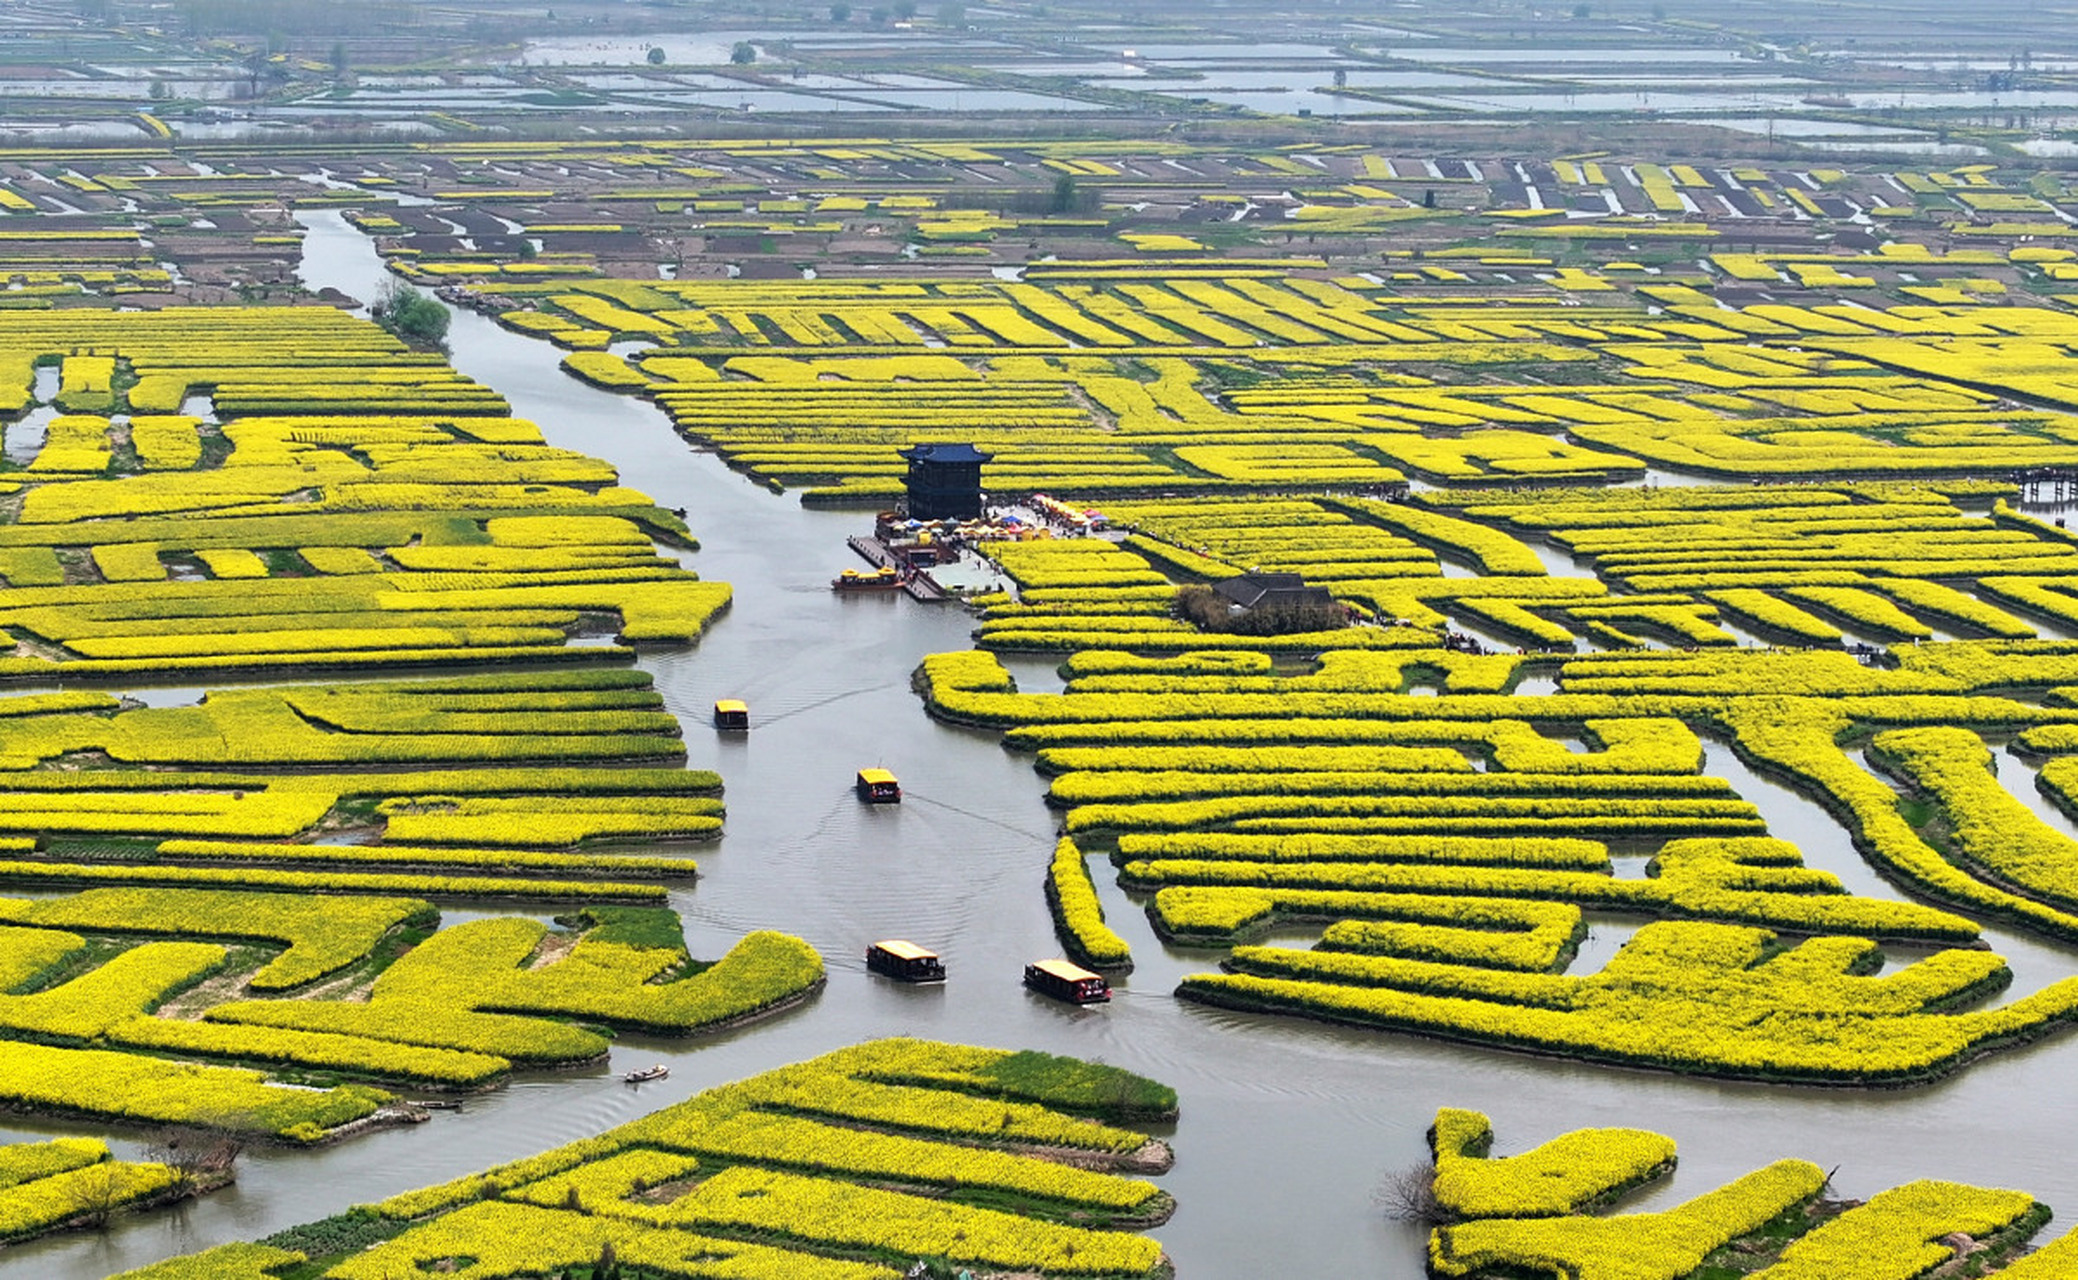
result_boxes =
[24,212,2078,1280]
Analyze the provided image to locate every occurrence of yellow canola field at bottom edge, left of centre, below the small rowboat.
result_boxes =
[137,1039,1174,1280]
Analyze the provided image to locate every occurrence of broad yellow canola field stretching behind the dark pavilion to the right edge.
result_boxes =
[471,260,2078,503]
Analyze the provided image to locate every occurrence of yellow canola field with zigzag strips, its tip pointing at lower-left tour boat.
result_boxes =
[0,887,823,1088]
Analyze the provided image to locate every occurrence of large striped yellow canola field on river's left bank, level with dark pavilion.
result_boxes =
[0,308,727,677]
